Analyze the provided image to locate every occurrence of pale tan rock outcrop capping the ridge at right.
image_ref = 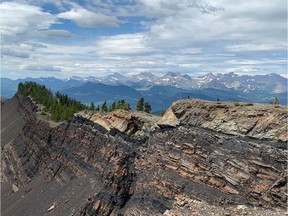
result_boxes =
[162,100,288,142]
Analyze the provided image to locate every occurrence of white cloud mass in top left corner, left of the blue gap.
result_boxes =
[0,2,57,62]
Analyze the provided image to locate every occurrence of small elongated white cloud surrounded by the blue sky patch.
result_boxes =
[58,8,118,28]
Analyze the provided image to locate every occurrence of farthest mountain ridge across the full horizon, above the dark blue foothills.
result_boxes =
[1,72,287,93]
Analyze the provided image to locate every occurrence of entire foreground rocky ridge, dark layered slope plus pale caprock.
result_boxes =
[1,97,287,216]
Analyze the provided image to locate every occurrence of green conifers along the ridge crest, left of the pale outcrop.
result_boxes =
[18,81,152,122]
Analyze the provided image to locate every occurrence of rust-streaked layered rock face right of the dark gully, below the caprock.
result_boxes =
[139,127,287,207]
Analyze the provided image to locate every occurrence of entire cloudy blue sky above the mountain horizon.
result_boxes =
[0,0,287,79]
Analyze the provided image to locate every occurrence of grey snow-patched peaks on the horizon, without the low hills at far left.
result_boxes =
[66,72,287,93]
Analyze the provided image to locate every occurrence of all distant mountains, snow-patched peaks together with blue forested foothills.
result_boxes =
[1,72,287,111]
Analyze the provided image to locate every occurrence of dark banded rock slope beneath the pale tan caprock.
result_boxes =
[1,99,287,215]
